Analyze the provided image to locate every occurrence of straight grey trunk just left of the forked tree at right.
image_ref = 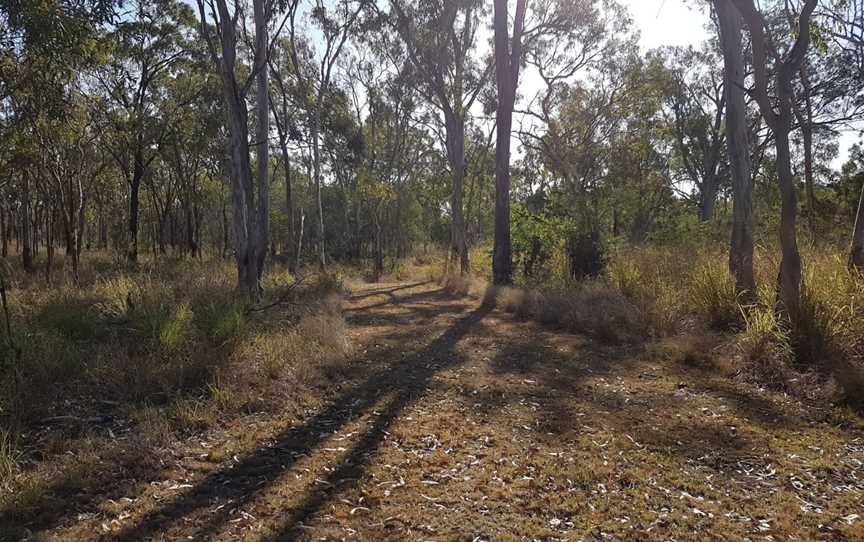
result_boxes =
[714,0,756,294]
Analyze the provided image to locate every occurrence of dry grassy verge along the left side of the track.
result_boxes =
[0,254,347,539]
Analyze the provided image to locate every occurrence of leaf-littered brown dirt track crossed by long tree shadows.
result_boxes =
[5,282,864,541]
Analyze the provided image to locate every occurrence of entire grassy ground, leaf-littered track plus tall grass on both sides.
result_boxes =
[0,253,864,540]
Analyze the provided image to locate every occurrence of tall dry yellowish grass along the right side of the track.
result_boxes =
[452,246,864,406]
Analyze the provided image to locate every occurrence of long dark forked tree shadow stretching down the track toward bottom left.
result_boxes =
[115,307,490,541]
